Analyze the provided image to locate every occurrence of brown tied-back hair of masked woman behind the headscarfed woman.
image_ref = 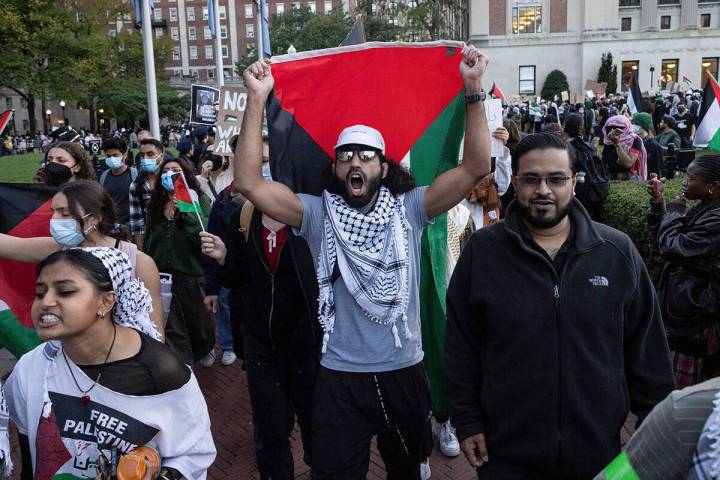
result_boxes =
[58,180,115,235]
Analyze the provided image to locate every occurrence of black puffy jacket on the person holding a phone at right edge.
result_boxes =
[648,203,720,344]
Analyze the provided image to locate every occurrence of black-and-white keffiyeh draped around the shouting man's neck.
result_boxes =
[318,187,412,353]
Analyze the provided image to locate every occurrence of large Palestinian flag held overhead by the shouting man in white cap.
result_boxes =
[267,41,465,414]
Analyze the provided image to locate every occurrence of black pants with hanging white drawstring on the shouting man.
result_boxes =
[312,362,431,480]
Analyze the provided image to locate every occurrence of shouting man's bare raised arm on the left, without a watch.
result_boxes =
[233,60,303,227]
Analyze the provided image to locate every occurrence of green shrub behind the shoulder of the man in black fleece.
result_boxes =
[602,176,682,284]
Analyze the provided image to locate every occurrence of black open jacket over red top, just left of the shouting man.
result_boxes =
[220,209,322,348]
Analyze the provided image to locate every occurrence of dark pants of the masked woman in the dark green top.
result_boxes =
[165,272,215,365]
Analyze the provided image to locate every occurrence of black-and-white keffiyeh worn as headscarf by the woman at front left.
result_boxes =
[73,247,161,340]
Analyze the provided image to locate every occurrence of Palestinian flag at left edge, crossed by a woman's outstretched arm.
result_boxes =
[0,183,55,358]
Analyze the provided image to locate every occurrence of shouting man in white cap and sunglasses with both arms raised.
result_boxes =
[234,46,490,479]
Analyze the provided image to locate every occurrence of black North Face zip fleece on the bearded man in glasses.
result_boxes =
[445,200,674,478]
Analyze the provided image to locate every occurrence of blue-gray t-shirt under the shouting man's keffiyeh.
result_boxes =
[296,187,431,372]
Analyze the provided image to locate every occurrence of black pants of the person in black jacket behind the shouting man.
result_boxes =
[245,334,318,480]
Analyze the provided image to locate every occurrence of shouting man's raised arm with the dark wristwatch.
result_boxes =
[425,46,490,218]
